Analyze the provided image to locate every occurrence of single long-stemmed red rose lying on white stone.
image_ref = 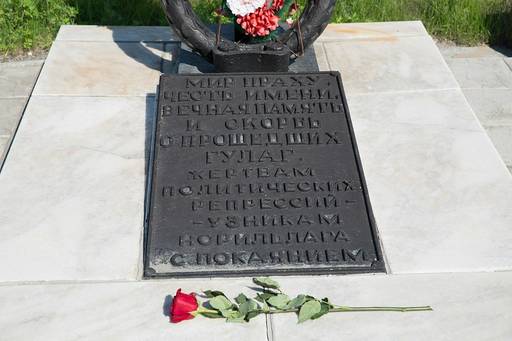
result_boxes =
[169,277,432,323]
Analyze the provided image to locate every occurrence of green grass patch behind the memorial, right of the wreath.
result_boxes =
[332,0,512,45]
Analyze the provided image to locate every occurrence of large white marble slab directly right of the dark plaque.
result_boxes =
[349,91,512,273]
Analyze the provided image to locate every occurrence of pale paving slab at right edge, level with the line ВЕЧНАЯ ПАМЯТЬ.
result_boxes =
[463,89,512,125]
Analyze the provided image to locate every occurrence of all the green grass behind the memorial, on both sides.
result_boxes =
[0,0,512,55]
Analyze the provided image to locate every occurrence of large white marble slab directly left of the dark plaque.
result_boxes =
[0,97,155,282]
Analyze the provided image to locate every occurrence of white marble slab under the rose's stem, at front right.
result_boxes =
[272,272,512,341]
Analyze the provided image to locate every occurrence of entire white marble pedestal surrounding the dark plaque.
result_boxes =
[0,22,512,341]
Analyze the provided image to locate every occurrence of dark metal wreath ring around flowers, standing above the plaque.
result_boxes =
[162,0,336,72]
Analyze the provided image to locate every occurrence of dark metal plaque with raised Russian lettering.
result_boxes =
[144,72,384,277]
